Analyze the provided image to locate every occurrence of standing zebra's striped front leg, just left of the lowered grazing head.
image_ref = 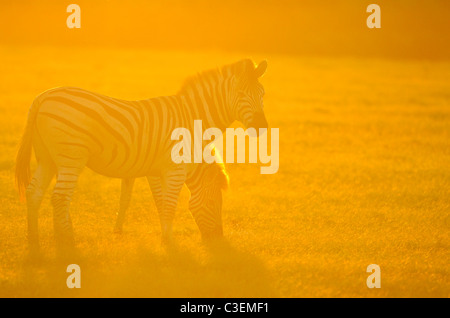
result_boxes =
[155,166,186,244]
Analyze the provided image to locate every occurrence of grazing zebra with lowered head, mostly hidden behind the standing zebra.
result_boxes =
[114,158,229,240]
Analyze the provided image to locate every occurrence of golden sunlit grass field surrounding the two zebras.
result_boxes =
[0,46,450,297]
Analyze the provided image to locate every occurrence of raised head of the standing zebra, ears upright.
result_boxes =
[232,59,268,130]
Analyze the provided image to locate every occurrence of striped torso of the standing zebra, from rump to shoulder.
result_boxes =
[36,87,182,178]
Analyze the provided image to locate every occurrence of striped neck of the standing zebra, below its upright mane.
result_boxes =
[177,70,234,131]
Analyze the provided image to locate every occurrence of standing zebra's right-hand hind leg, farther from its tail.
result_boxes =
[51,166,82,255]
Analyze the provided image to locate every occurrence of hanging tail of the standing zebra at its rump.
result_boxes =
[16,100,38,202]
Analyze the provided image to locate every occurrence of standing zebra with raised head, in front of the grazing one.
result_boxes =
[16,59,267,251]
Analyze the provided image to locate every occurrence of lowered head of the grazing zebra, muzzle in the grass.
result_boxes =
[186,163,229,241]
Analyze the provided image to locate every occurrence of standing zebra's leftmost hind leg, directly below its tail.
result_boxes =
[26,159,56,255]
